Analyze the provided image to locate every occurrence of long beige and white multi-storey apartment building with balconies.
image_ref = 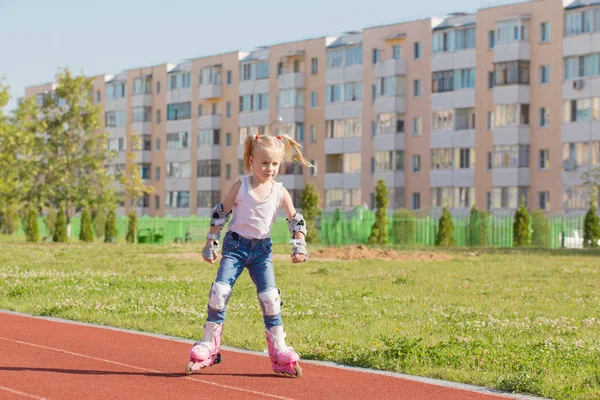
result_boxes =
[25,0,600,216]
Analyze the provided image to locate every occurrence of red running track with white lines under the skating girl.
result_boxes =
[0,312,512,400]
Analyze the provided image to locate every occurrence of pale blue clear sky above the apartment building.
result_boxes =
[0,0,496,110]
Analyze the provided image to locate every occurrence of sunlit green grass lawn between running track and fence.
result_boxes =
[0,239,600,399]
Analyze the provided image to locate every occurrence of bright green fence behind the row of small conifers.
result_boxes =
[15,207,583,248]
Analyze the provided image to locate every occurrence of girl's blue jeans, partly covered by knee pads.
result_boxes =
[206,231,283,329]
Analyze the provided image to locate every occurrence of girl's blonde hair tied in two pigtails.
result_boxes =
[244,135,316,175]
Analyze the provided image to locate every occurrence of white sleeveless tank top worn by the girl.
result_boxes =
[228,176,283,239]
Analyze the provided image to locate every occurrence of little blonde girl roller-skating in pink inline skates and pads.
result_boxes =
[186,135,314,377]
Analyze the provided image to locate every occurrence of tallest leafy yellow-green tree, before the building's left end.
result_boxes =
[41,68,109,227]
